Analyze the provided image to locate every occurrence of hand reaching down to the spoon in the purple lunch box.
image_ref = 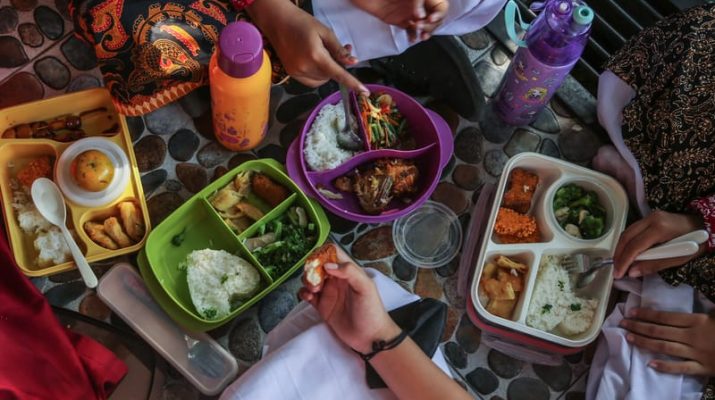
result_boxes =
[248,0,369,93]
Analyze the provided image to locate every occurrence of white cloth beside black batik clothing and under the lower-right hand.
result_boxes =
[586,71,704,400]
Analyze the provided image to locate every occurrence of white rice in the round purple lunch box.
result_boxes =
[303,101,354,171]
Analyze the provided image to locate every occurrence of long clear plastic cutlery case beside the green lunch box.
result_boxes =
[97,263,238,396]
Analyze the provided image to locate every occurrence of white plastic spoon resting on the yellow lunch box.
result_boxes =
[30,178,97,289]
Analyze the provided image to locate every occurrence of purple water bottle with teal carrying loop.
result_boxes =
[494,0,593,125]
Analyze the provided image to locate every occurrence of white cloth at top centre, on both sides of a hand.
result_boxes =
[312,0,506,61]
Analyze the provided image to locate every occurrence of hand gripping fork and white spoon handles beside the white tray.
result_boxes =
[613,210,705,279]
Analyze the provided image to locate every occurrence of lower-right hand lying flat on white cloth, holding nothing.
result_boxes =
[621,308,715,376]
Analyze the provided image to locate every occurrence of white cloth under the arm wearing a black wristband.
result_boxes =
[221,268,451,400]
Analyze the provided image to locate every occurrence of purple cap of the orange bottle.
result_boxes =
[218,21,263,78]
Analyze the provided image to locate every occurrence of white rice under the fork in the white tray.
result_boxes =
[526,256,598,336]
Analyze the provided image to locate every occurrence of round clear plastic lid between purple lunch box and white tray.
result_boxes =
[392,200,462,268]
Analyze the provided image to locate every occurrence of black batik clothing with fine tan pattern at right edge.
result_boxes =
[606,5,715,400]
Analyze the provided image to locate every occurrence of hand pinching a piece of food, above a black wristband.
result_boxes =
[298,248,400,353]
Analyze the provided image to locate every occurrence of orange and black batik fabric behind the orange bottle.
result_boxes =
[70,0,285,115]
